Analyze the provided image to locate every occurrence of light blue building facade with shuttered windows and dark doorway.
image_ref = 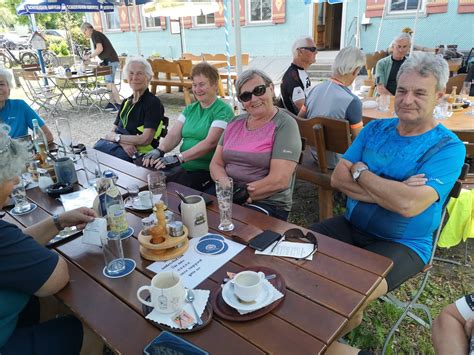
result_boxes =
[87,0,474,58]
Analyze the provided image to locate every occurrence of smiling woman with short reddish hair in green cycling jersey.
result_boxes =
[143,63,234,191]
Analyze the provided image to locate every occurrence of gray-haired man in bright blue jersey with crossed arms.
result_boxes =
[318,53,466,354]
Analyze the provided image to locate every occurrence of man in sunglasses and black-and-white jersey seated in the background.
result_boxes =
[281,37,318,116]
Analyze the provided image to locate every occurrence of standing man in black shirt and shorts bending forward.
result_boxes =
[81,22,120,113]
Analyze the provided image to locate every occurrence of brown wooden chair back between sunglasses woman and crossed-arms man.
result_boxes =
[294,116,352,221]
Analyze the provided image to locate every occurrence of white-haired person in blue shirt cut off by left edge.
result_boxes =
[0,68,53,143]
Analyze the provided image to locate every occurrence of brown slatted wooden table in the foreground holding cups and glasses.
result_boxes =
[4,152,392,355]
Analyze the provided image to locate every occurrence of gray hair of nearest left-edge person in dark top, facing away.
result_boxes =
[0,123,29,183]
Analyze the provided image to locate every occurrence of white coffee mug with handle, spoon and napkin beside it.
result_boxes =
[137,271,185,313]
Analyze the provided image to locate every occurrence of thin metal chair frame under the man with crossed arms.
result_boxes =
[381,164,468,354]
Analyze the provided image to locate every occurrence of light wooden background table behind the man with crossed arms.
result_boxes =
[362,96,474,133]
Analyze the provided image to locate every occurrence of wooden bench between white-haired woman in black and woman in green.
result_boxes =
[150,59,192,105]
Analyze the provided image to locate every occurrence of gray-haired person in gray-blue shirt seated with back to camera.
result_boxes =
[306,47,365,169]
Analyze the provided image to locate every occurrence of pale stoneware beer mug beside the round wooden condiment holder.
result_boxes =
[181,195,209,238]
